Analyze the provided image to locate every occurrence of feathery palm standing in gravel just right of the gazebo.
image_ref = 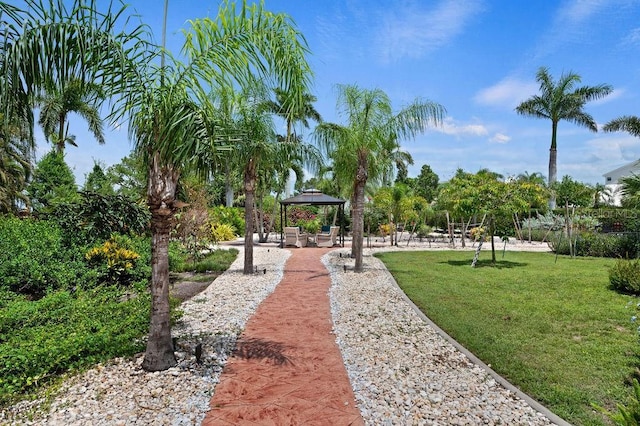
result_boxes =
[314,85,444,272]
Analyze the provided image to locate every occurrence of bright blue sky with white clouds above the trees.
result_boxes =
[45,0,640,184]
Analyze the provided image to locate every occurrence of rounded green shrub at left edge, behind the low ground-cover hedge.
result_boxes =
[0,217,95,298]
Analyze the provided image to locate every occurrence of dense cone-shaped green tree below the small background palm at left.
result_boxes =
[27,150,79,211]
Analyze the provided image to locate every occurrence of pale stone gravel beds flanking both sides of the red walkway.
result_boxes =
[0,240,564,426]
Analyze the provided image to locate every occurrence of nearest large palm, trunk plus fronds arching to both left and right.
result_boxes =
[0,0,310,371]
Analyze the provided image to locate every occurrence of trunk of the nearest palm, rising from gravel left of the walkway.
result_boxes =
[142,155,179,371]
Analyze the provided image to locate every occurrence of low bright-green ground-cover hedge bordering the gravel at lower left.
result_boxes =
[0,287,150,404]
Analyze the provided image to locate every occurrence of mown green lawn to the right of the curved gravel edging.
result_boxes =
[379,251,640,425]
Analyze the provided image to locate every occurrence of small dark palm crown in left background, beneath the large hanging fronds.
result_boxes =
[36,78,104,152]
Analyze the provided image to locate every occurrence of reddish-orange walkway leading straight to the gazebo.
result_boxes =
[202,247,364,426]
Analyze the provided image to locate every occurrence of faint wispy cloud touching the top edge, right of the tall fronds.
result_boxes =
[376,0,481,61]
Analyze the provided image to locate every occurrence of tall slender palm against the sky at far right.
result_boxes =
[516,67,613,208]
